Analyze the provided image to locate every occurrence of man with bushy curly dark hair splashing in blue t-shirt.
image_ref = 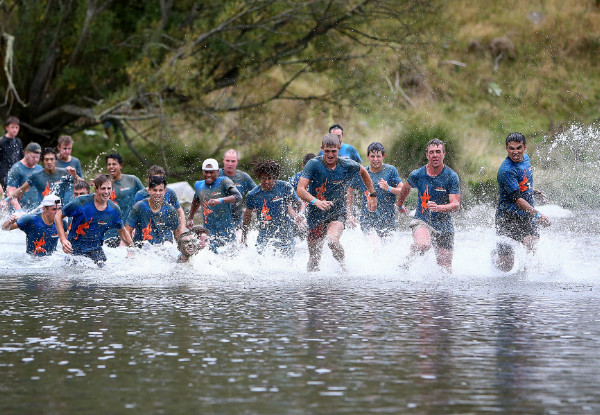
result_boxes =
[242,160,306,256]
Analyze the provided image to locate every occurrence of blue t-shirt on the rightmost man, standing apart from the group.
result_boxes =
[496,154,534,217]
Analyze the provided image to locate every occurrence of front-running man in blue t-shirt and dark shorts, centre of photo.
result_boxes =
[297,134,377,271]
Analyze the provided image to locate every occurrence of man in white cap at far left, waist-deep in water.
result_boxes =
[2,195,61,256]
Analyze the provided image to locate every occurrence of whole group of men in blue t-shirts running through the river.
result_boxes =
[0,117,550,272]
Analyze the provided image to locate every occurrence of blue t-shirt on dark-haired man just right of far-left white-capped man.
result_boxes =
[62,194,123,253]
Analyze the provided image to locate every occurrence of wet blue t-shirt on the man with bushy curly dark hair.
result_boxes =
[246,180,300,245]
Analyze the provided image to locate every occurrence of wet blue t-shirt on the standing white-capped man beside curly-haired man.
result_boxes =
[194,177,237,247]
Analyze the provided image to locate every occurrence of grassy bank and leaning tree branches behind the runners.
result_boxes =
[0,0,600,206]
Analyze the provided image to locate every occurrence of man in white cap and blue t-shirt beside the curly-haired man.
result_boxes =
[187,159,242,248]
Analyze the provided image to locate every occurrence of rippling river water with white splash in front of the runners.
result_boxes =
[0,205,600,414]
